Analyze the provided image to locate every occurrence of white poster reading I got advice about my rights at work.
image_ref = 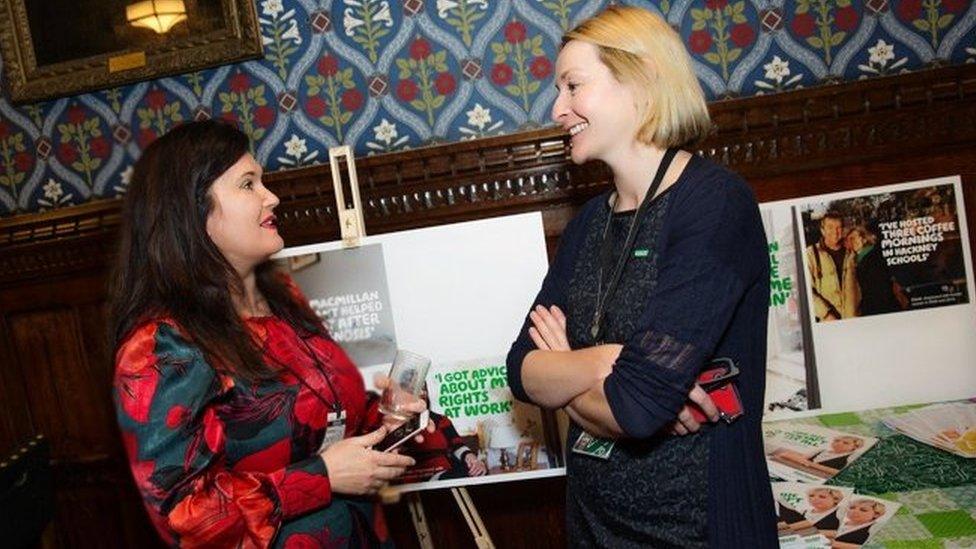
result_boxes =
[276,213,564,491]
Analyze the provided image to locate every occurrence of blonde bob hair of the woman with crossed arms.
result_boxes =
[563,6,712,148]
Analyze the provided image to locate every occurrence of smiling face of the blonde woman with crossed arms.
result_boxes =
[552,40,641,166]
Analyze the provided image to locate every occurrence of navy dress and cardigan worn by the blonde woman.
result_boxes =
[508,156,778,548]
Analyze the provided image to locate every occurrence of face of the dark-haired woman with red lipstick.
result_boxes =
[207,154,284,273]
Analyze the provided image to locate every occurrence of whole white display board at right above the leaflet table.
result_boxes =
[761,176,976,419]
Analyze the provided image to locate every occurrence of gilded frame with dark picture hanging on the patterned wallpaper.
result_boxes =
[0,0,262,104]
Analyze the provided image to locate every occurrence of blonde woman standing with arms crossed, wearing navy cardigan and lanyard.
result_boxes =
[508,7,777,548]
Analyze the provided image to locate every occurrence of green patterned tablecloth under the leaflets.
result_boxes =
[772,407,976,549]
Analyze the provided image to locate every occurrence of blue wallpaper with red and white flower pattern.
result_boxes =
[0,0,976,216]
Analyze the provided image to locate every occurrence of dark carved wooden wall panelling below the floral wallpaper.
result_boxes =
[0,65,976,549]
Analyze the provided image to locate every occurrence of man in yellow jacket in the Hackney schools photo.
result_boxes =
[806,211,861,322]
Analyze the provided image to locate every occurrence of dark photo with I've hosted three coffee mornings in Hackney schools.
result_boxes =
[798,183,969,322]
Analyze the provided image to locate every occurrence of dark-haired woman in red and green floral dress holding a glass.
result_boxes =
[110,121,423,547]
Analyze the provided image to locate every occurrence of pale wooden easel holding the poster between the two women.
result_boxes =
[329,145,495,549]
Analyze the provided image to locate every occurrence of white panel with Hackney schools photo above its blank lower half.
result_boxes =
[796,176,976,411]
